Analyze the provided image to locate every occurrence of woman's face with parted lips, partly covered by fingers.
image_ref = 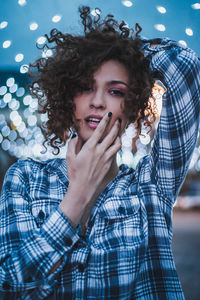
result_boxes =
[74,60,129,143]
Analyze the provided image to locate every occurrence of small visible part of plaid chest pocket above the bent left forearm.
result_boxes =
[31,198,59,227]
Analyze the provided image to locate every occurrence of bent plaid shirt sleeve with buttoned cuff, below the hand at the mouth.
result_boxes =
[0,163,79,295]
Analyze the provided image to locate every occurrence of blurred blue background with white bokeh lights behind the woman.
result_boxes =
[0,0,200,300]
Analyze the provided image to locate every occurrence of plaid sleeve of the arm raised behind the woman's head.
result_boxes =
[143,39,200,202]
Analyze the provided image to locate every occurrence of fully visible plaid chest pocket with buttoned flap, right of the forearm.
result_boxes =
[91,195,142,251]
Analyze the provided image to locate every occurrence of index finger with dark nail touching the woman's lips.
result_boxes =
[88,112,112,145]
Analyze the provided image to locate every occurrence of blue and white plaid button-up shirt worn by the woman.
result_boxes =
[0,39,200,300]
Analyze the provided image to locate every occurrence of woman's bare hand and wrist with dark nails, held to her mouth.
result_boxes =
[60,114,121,227]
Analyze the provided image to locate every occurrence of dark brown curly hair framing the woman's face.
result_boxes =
[29,6,154,153]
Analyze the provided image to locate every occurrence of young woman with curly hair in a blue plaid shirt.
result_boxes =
[0,7,200,300]
